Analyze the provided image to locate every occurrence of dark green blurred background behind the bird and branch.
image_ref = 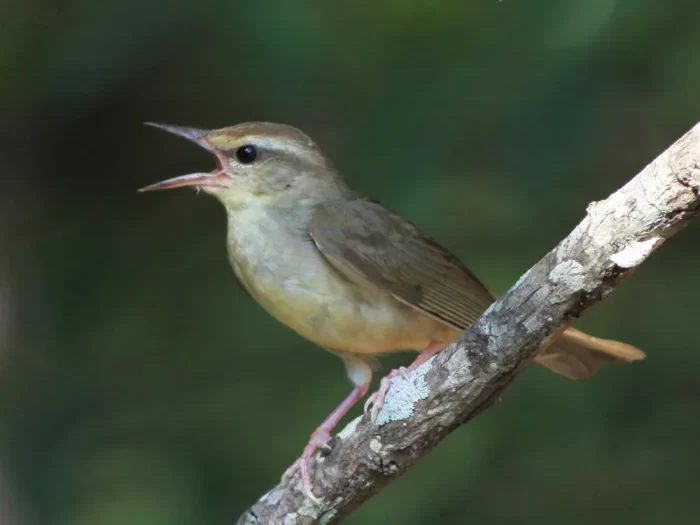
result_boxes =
[0,0,700,525]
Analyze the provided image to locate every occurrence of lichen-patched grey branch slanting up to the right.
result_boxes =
[238,123,700,525]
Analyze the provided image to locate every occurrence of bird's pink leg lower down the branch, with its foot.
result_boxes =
[282,355,372,504]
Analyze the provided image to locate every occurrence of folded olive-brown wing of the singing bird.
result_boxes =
[309,199,494,329]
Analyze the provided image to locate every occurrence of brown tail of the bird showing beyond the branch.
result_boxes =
[535,328,646,379]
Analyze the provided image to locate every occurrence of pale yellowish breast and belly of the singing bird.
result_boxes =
[228,203,459,354]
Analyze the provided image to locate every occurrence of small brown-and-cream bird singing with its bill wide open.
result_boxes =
[139,122,645,502]
